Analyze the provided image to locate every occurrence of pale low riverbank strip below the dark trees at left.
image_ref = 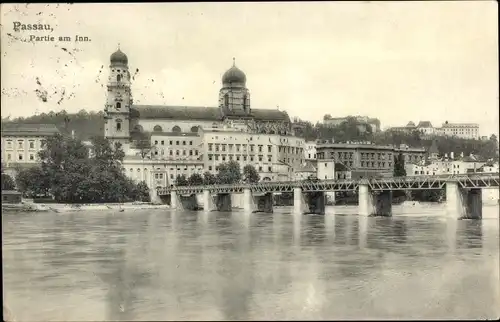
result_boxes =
[2,202,170,213]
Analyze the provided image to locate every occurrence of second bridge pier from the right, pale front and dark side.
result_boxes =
[358,180,392,217]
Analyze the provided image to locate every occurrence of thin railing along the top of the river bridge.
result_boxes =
[158,173,499,193]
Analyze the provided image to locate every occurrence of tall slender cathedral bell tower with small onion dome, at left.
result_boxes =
[104,48,132,151]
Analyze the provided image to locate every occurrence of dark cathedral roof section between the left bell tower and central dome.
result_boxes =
[130,105,222,121]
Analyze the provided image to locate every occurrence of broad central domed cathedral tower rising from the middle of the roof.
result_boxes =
[219,58,251,118]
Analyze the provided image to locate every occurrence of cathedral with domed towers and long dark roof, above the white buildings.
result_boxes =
[105,49,291,150]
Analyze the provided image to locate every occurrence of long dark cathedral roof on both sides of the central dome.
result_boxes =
[130,105,290,122]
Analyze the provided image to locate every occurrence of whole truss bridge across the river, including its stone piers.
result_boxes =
[157,173,500,218]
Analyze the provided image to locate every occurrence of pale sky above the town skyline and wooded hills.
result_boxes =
[1,1,499,136]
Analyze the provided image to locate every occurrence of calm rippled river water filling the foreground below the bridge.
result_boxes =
[2,205,500,321]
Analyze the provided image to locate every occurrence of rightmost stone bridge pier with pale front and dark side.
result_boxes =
[446,181,483,219]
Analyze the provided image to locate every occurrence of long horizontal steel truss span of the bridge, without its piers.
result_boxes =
[157,173,500,196]
